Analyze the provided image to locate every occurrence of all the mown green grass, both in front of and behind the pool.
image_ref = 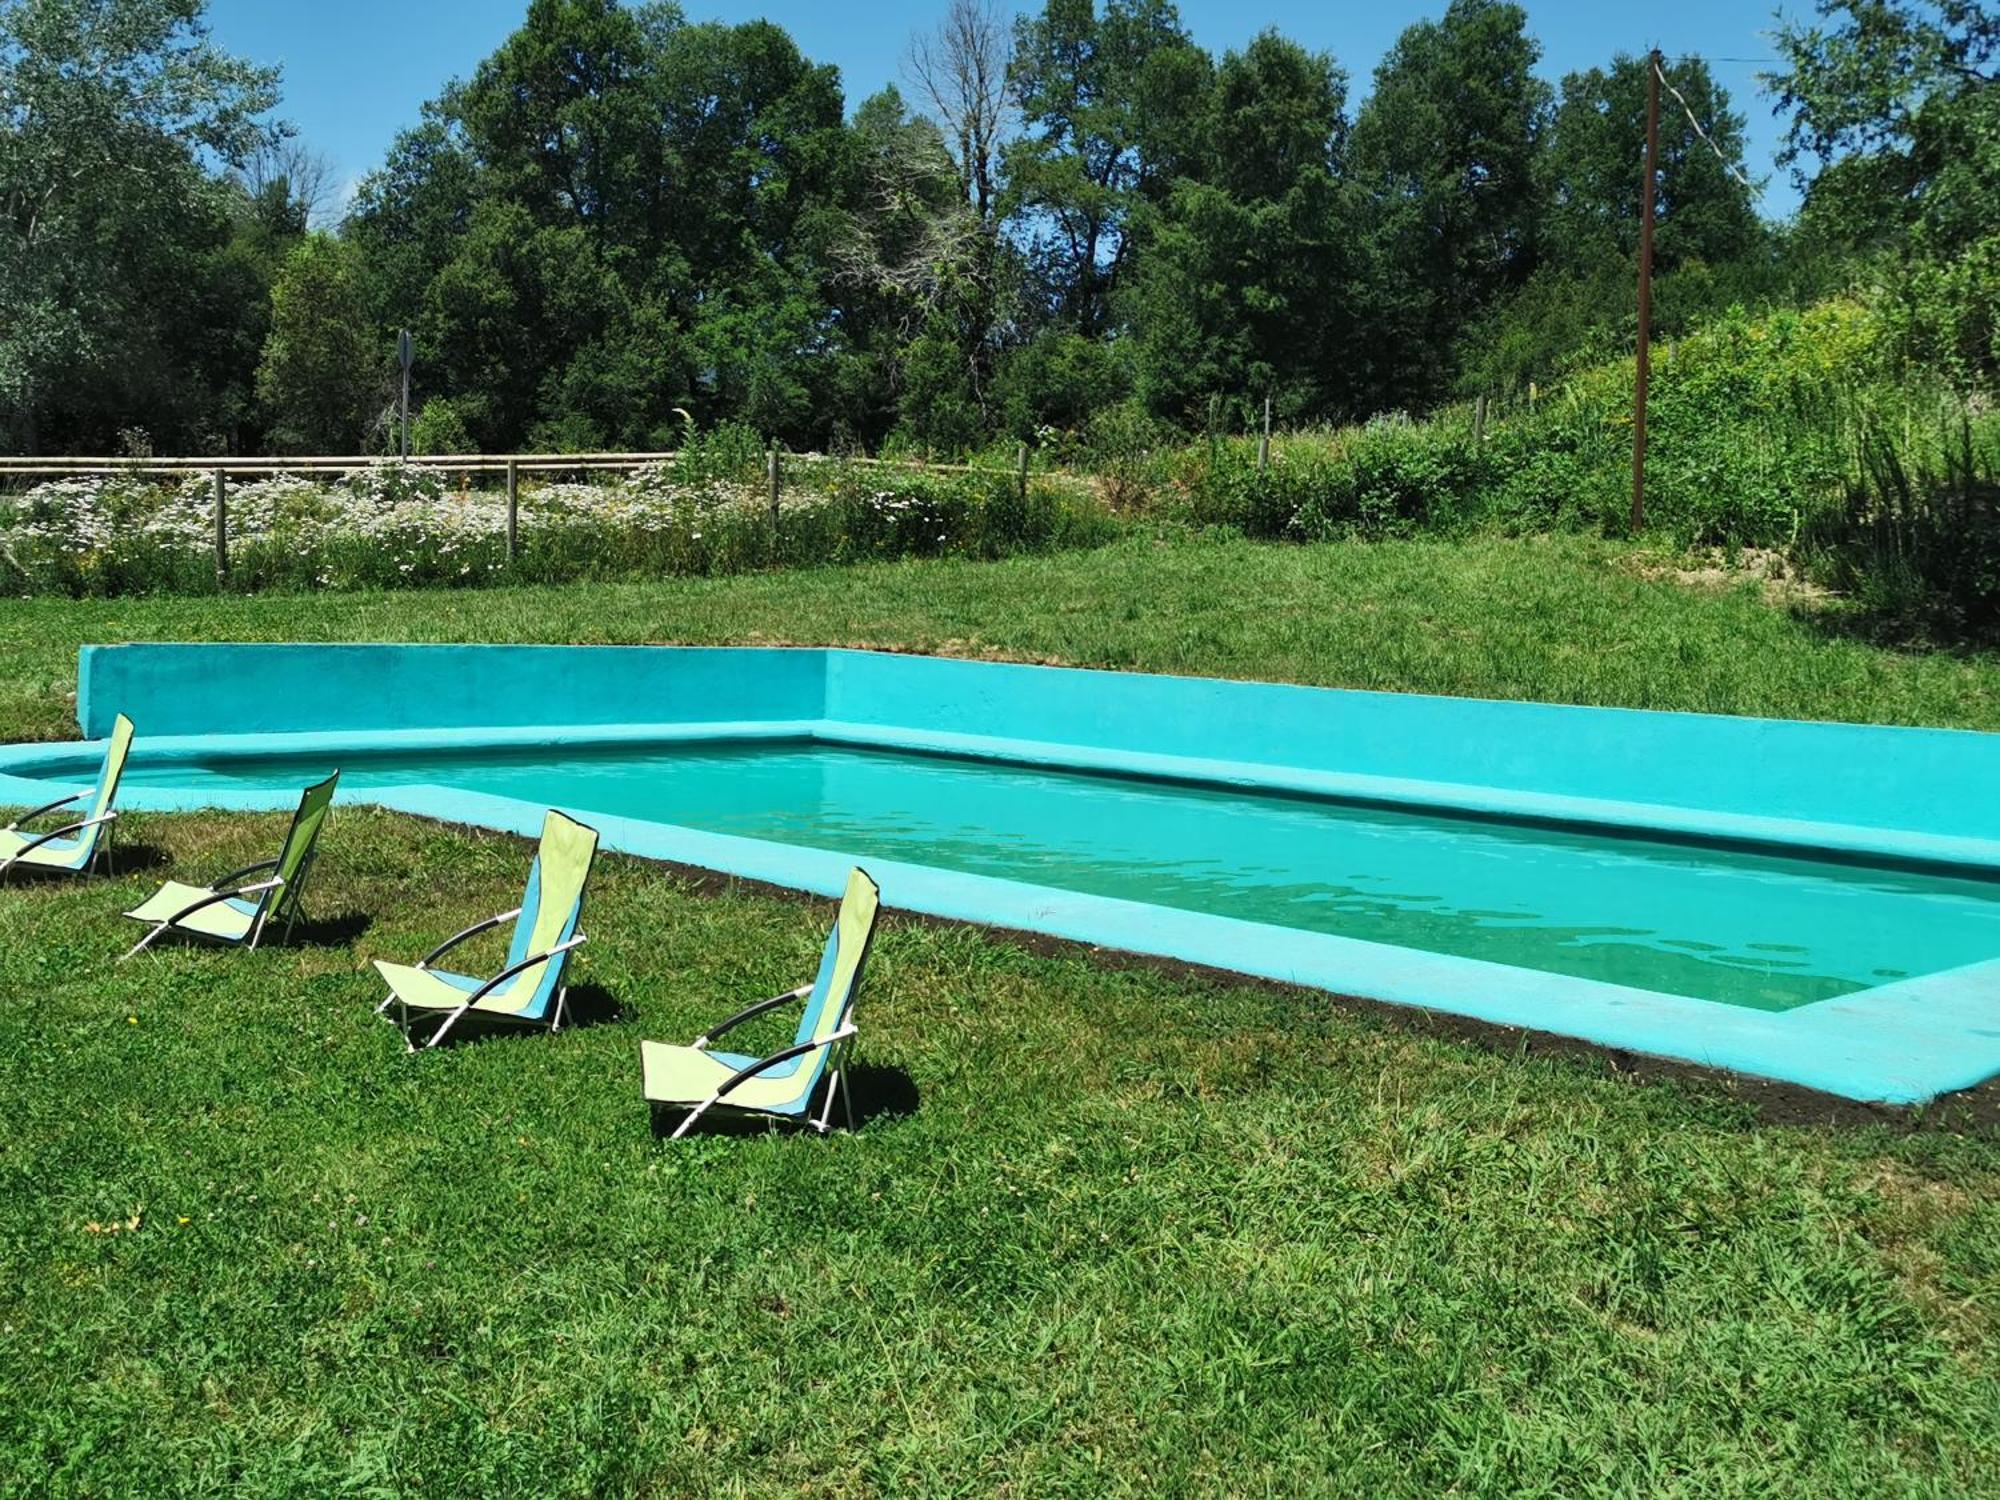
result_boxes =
[0,542,2000,1496]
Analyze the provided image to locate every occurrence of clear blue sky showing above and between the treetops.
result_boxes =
[210,0,1804,216]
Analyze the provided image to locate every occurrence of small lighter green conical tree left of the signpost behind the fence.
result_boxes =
[256,234,386,454]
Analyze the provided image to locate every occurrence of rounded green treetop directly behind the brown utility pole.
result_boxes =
[1542,54,1758,274]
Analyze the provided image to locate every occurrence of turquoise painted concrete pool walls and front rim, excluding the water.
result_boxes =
[15,646,2000,1104]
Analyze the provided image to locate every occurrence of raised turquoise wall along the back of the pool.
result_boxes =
[78,644,2000,872]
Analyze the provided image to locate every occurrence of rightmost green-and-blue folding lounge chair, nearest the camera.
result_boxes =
[640,870,882,1140]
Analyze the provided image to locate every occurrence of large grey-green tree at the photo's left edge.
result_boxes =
[0,0,278,452]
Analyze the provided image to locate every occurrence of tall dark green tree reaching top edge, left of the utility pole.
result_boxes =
[1350,0,1550,402]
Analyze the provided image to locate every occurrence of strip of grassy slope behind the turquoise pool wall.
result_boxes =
[0,540,2000,736]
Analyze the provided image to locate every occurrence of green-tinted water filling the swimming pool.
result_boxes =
[128,744,2000,1010]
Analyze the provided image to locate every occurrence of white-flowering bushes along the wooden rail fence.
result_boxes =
[0,462,1118,596]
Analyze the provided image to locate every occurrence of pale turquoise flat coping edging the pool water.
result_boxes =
[0,718,2000,1106]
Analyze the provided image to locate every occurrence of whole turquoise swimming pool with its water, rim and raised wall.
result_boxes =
[0,646,2000,1102]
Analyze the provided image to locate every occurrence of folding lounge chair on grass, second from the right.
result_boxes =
[376,812,598,1052]
